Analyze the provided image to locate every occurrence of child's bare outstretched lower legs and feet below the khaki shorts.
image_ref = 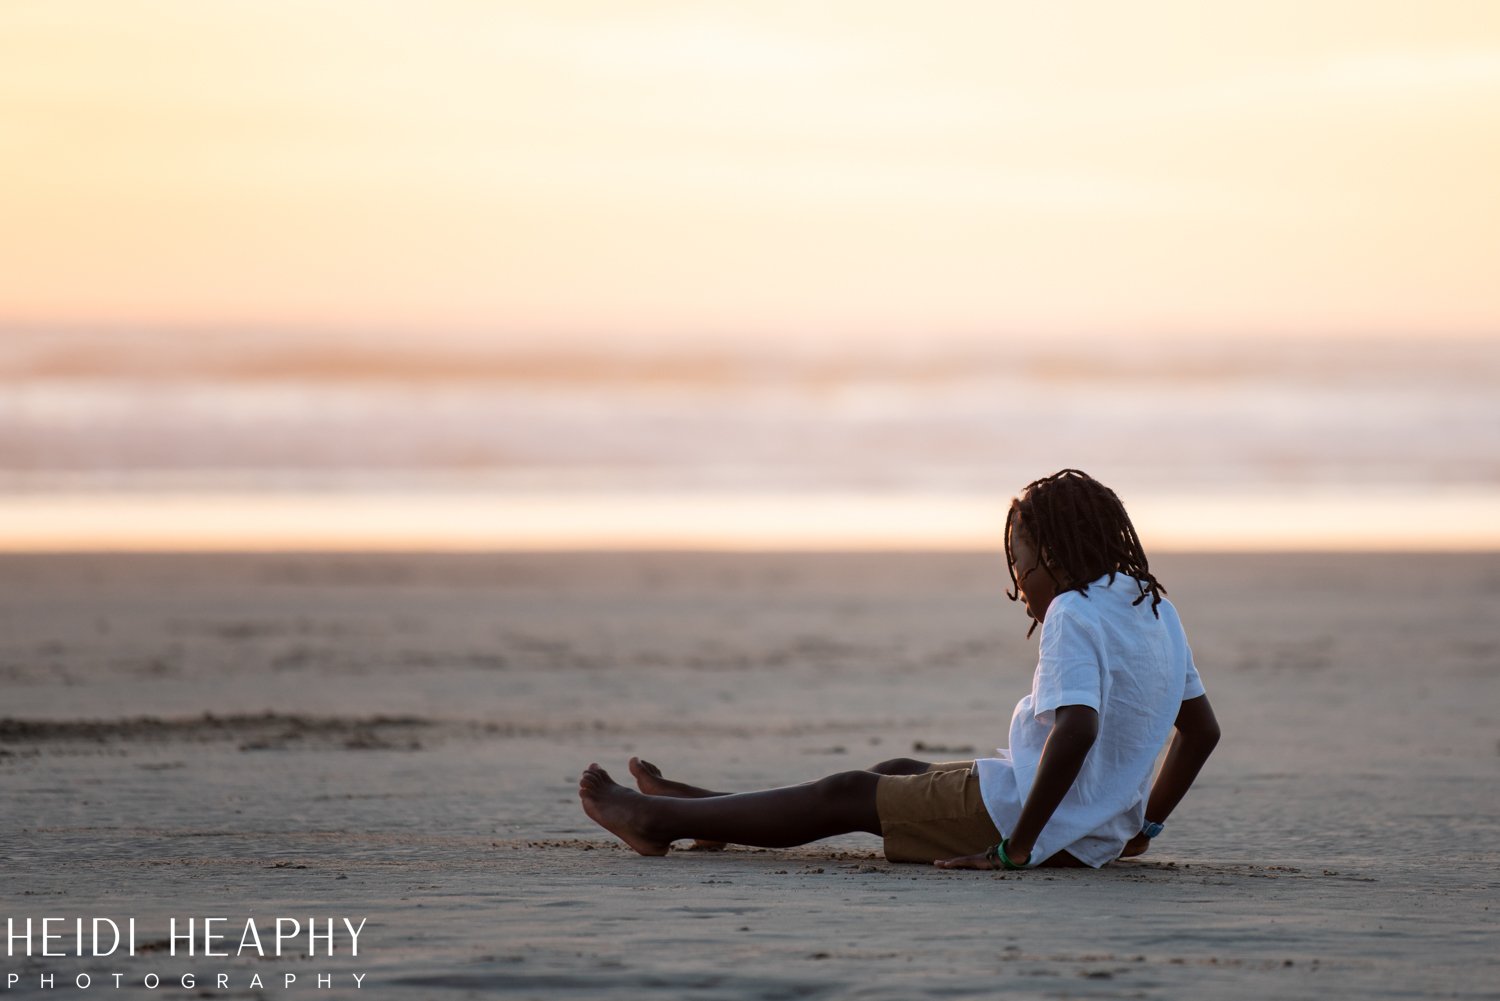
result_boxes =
[578,764,881,855]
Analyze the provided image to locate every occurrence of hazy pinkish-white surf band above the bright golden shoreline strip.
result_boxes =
[0,339,1500,543]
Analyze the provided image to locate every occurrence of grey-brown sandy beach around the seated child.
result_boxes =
[0,554,1500,1001]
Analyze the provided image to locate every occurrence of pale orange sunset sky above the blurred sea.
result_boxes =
[0,0,1500,345]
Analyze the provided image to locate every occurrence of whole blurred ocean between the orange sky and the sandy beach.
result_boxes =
[0,332,1500,548]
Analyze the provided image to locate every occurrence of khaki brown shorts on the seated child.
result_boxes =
[875,761,1001,863]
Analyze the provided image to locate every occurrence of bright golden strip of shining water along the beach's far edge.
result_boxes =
[0,488,1500,554]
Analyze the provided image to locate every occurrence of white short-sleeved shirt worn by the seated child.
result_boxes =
[975,573,1203,866]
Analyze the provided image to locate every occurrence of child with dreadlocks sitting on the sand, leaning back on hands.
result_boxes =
[579,470,1220,869]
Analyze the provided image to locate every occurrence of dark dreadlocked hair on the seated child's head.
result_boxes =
[1005,470,1167,636]
